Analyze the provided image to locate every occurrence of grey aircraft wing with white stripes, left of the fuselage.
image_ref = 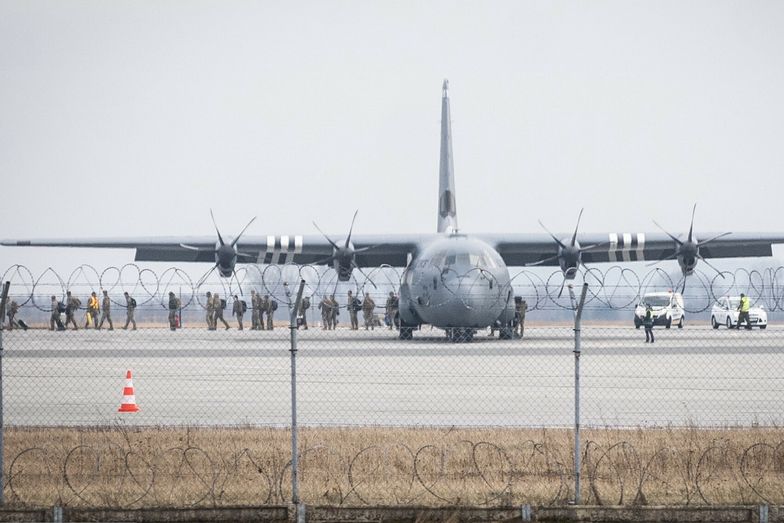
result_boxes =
[0,235,428,267]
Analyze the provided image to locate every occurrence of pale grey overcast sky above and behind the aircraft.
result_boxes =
[0,0,784,270]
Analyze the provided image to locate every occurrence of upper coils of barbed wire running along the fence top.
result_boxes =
[3,263,784,313]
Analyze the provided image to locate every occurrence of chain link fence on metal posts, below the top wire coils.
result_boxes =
[2,270,784,507]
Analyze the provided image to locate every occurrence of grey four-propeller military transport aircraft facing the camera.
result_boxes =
[0,80,784,341]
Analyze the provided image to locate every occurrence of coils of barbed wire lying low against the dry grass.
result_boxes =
[7,440,784,508]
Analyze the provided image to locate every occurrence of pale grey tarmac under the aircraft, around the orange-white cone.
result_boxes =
[2,325,784,427]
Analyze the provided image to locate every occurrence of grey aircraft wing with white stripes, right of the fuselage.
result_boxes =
[486,233,784,267]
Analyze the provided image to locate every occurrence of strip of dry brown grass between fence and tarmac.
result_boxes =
[5,427,784,507]
